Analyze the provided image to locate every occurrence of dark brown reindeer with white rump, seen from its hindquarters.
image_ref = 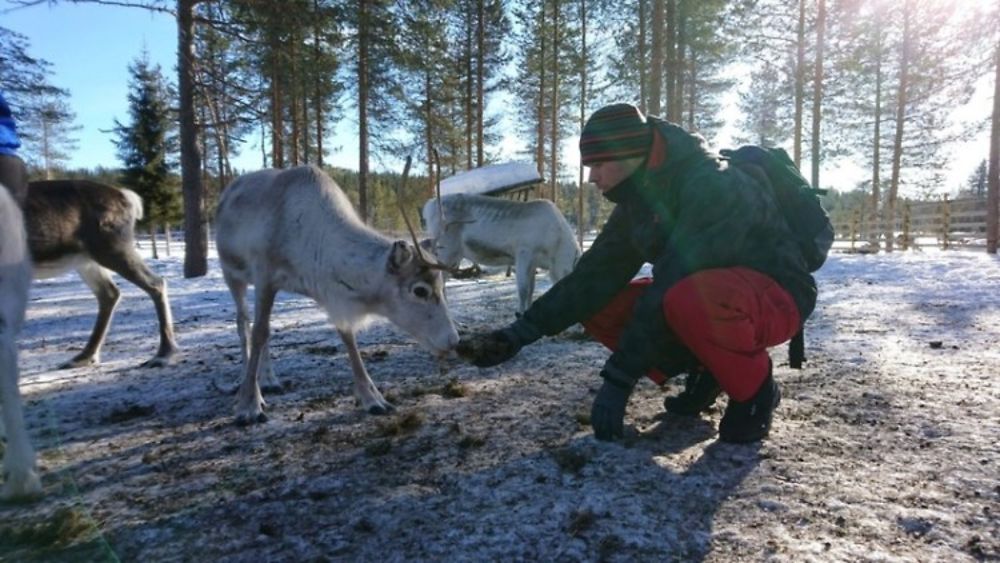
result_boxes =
[24,180,178,369]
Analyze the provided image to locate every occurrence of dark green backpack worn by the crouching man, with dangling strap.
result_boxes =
[719,145,834,369]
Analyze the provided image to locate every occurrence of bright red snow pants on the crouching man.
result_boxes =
[583,267,799,401]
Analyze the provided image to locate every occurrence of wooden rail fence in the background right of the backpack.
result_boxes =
[834,196,987,250]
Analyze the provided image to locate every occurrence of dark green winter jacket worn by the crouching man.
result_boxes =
[521,117,816,377]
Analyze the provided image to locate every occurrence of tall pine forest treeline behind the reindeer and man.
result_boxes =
[0,0,1000,275]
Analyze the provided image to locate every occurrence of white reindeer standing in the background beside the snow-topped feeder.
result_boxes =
[423,194,580,313]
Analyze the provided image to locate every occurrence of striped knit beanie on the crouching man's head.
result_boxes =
[580,104,652,166]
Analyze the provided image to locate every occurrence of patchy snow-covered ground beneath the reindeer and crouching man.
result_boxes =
[0,243,1000,562]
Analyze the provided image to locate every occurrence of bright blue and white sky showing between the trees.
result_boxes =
[0,2,992,195]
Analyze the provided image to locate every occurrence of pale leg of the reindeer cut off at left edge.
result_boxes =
[0,332,42,499]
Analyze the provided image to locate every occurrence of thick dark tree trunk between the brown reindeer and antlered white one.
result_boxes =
[177,0,208,278]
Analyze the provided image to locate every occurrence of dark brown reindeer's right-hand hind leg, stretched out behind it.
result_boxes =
[94,245,179,367]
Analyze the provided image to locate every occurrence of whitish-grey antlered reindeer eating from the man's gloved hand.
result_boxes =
[216,166,458,424]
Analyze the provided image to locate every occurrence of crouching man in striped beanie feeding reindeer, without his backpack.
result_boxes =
[458,104,816,443]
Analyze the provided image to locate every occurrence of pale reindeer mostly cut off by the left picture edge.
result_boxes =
[0,185,42,498]
